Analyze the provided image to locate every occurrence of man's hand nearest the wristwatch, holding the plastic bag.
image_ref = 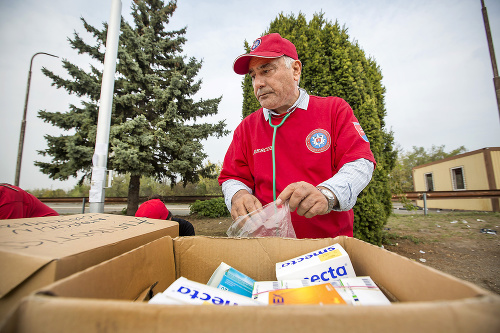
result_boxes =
[276,182,328,218]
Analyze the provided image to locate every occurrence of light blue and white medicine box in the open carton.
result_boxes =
[207,262,255,297]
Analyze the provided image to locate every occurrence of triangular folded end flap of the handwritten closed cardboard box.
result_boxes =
[0,252,52,298]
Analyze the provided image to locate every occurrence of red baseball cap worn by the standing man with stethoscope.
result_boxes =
[233,33,299,75]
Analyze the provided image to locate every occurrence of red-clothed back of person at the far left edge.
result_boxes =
[0,183,59,220]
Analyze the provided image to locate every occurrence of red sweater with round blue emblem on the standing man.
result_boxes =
[219,96,375,238]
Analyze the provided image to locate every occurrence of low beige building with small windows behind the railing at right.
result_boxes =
[412,147,500,212]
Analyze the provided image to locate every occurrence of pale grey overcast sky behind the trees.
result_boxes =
[0,0,500,189]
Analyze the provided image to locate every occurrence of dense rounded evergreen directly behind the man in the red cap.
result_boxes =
[243,13,396,244]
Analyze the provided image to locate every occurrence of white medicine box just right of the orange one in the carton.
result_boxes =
[337,276,391,306]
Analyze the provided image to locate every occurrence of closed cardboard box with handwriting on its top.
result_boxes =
[0,214,179,322]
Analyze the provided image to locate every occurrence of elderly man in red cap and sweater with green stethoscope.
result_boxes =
[219,33,375,238]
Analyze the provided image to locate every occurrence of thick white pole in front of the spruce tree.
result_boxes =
[89,0,122,213]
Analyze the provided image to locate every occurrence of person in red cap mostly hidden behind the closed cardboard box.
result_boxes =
[135,196,195,236]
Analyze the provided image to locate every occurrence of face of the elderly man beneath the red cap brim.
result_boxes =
[248,57,301,113]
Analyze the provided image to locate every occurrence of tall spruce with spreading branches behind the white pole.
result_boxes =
[35,0,228,215]
